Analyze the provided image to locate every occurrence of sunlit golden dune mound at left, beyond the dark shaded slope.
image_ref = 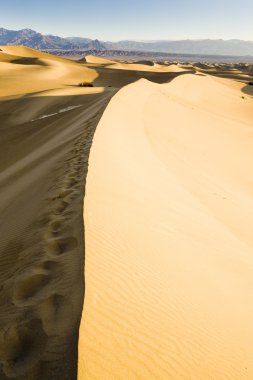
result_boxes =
[0,46,97,97]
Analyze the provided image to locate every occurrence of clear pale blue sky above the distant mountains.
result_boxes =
[0,0,253,41]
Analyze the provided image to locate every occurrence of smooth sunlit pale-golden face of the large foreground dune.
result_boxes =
[79,75,253,380]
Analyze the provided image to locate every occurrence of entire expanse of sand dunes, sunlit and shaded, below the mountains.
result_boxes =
[0,46,253,380]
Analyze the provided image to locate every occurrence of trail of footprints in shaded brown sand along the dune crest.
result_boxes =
[0,112,101,380]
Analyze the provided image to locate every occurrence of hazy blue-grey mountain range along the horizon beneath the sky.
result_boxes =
[0,28,253,56]
